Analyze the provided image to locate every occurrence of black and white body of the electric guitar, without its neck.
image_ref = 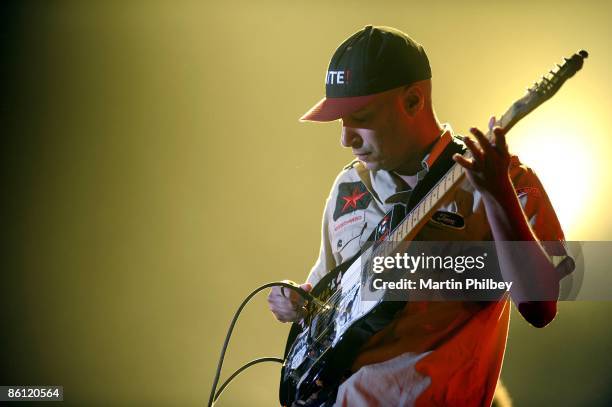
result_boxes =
[279,253,405,406]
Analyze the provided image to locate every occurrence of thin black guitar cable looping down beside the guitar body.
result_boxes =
[208,281,320,407]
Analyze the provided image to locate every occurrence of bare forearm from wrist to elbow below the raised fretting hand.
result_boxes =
[483,178,559,326]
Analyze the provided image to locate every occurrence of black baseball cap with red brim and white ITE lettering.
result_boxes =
[300,25,431,122]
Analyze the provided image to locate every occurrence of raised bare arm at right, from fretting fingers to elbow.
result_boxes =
[454,122,559,327]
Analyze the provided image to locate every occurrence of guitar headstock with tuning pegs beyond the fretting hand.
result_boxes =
[502,50,589,130]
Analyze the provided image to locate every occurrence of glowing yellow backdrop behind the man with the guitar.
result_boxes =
[0,1,612,406]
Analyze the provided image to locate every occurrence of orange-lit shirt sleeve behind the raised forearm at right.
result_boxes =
[510,157,574,279]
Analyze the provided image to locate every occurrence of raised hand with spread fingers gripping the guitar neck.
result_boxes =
[453,117,512,198]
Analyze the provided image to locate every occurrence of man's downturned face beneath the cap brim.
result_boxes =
[341,91,420,171]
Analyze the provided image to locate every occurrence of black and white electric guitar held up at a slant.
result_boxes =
[279,51,588,406]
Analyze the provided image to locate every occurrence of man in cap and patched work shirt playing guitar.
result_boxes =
[268,26,571,406]
